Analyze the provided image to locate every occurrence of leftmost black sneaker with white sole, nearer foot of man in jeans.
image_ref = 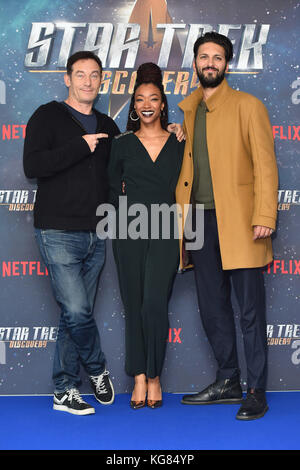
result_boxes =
[53,388,95,416]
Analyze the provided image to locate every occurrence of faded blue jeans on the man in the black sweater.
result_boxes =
[35,229,105,393]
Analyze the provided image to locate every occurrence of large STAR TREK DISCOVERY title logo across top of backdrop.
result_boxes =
[24,0,270,118]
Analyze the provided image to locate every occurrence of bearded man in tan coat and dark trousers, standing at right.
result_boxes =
[176,32,278,420]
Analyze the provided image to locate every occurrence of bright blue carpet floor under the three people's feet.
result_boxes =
[0,392,300,450]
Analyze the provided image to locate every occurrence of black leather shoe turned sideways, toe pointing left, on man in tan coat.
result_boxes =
[181,378,243,405]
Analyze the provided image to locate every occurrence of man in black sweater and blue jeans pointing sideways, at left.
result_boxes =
[24,51,120,415]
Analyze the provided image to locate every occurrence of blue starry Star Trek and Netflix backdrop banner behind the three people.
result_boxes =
[0,0,300,395]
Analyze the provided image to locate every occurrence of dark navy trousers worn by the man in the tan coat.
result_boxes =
[191,210,267,389]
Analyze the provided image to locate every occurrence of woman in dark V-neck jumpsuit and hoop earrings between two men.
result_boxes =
[109,64,184,408]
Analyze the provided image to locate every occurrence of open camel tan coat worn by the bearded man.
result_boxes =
[176,79,278,269]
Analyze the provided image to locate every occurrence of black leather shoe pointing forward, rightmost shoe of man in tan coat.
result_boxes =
[236,390,269,421]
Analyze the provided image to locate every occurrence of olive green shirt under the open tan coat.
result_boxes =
[192,101,215,209]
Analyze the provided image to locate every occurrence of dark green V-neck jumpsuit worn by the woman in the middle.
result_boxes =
[108,132,184,378]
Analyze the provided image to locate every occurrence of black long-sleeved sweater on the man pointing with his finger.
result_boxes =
[23,101,120,230]
